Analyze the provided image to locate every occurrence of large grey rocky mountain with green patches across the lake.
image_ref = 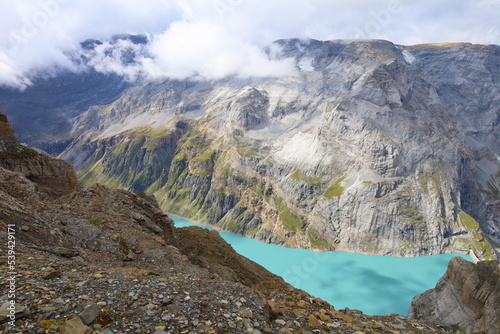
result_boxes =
[0,39,500,258]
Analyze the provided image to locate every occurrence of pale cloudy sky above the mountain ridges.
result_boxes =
[0,0,500,89]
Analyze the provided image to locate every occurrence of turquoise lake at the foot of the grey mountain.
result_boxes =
[172,217,471,315]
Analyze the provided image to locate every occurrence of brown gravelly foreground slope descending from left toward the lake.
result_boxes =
[0,114,462,334]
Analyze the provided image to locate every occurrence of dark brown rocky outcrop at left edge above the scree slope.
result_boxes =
[0,114,80,198]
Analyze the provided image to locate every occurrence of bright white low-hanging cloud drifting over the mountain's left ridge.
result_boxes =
[73,22,294,81]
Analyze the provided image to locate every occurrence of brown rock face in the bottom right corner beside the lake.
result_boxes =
[409,257,500,334]
